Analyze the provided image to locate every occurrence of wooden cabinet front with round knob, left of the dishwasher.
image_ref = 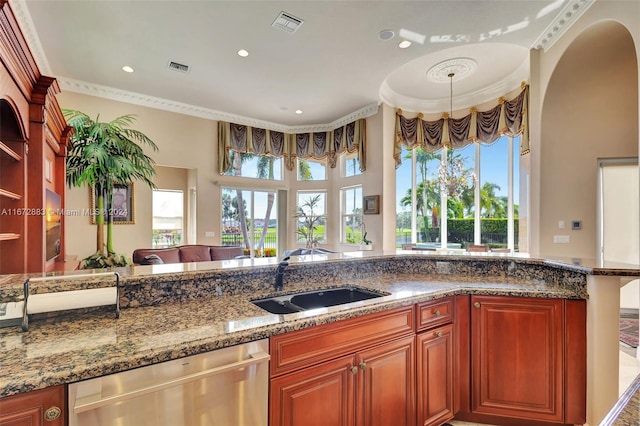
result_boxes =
[0,385,67,426]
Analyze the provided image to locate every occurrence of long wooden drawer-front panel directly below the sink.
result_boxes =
[269,306,415,376]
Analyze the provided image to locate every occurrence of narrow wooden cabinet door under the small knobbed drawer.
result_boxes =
[416,324,454,426]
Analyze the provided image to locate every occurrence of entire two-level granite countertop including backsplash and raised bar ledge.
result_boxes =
[5,251,640,397]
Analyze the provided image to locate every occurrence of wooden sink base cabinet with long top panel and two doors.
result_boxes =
[269,307,415,426]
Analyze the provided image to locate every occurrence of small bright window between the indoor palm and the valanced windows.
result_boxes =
[151,189,184,248]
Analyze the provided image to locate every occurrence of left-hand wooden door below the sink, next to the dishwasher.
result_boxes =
[269,356,358,426]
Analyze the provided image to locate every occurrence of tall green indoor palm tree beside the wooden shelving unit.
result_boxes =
[63,110,158,264]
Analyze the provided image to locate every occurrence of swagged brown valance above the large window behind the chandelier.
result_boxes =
[393,83,529,168]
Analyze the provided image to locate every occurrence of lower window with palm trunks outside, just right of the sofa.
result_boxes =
[222,188,278,257]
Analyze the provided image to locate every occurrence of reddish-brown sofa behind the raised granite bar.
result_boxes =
[131,244,244,265]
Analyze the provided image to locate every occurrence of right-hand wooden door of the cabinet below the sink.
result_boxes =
[356,336,416,426]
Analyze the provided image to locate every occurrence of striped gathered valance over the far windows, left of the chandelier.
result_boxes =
[218,118,367,174]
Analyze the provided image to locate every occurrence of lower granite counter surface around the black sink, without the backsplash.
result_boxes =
[0,274,580,397]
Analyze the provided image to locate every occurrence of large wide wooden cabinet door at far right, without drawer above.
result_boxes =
[471,296,563,422]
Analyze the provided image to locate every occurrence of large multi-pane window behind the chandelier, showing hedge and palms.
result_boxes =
[396,136,520,251]
